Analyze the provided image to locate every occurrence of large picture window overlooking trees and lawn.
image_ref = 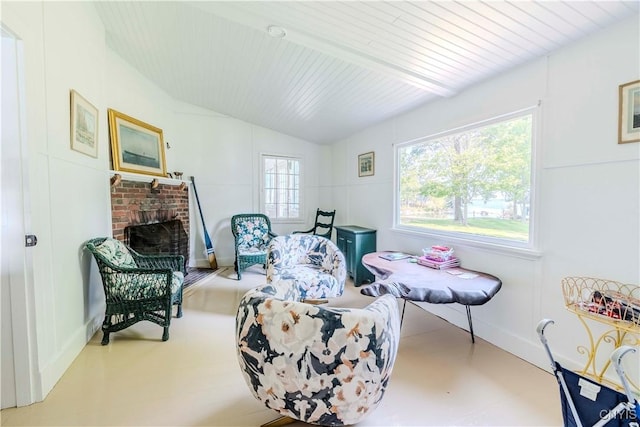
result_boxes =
[395,108,535,247]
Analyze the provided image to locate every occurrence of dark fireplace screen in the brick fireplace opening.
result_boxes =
[124,219,189,271]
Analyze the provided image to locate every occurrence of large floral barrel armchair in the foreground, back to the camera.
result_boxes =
[236,281,400,426]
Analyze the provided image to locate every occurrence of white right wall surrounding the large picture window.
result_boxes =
[333,12,640,374]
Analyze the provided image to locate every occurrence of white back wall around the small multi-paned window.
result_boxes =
[168,102,331,266]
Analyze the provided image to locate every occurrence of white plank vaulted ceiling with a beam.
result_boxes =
[95,1,640,143]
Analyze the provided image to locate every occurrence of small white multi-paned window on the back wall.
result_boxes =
[262,154,301,220]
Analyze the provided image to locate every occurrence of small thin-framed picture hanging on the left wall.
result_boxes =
[70,89,98,157]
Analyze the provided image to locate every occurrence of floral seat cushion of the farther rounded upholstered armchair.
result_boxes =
[274,264,342,299]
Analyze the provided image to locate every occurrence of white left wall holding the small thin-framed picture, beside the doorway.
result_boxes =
[2,2,110,400]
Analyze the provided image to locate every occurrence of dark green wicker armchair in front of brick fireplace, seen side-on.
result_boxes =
[85,237,184,345]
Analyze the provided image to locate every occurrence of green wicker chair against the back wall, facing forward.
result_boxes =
[231,213,275,280]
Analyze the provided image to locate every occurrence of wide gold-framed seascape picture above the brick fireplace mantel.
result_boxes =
[107,108,167,176]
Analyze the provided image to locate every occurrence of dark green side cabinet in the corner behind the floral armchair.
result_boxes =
[335,225,376,286]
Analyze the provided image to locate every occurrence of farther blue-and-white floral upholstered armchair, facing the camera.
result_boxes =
[267,234,347,299]
